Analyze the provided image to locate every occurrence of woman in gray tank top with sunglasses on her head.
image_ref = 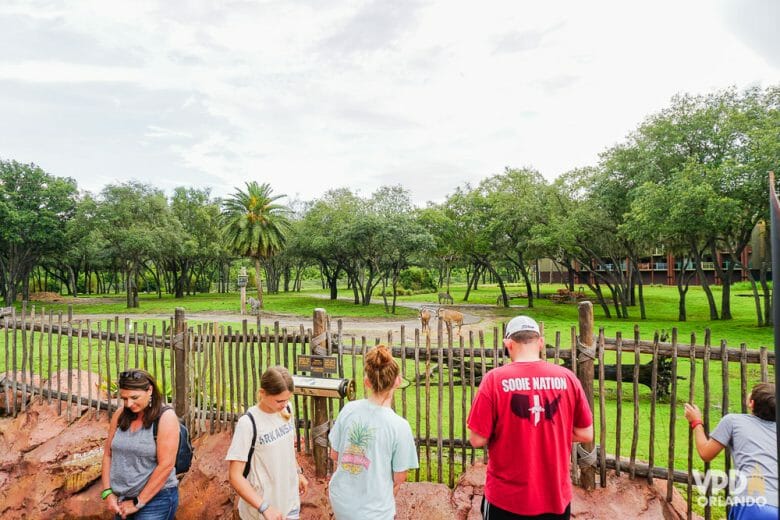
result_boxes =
[101,369,179,520]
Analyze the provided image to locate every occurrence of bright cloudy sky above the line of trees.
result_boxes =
[0,0,780,203]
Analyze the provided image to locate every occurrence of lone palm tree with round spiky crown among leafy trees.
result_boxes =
[222,181,290,308]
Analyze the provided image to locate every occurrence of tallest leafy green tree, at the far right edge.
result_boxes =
[628,87,780,322]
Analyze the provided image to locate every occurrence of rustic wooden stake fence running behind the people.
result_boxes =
[0,305,775,518]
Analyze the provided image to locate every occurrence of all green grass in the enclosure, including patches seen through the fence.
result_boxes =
[0,285,774,517]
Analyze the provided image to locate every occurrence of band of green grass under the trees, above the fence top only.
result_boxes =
[10,284,773,348]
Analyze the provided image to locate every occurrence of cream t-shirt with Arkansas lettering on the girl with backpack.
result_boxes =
[225,405,301,520]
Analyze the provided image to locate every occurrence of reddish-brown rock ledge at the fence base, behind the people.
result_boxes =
[0,399,698,520]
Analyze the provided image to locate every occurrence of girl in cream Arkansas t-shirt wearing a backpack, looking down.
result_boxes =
[225,366,309,520]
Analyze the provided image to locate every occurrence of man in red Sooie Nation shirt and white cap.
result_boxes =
[468,316,593,520]
